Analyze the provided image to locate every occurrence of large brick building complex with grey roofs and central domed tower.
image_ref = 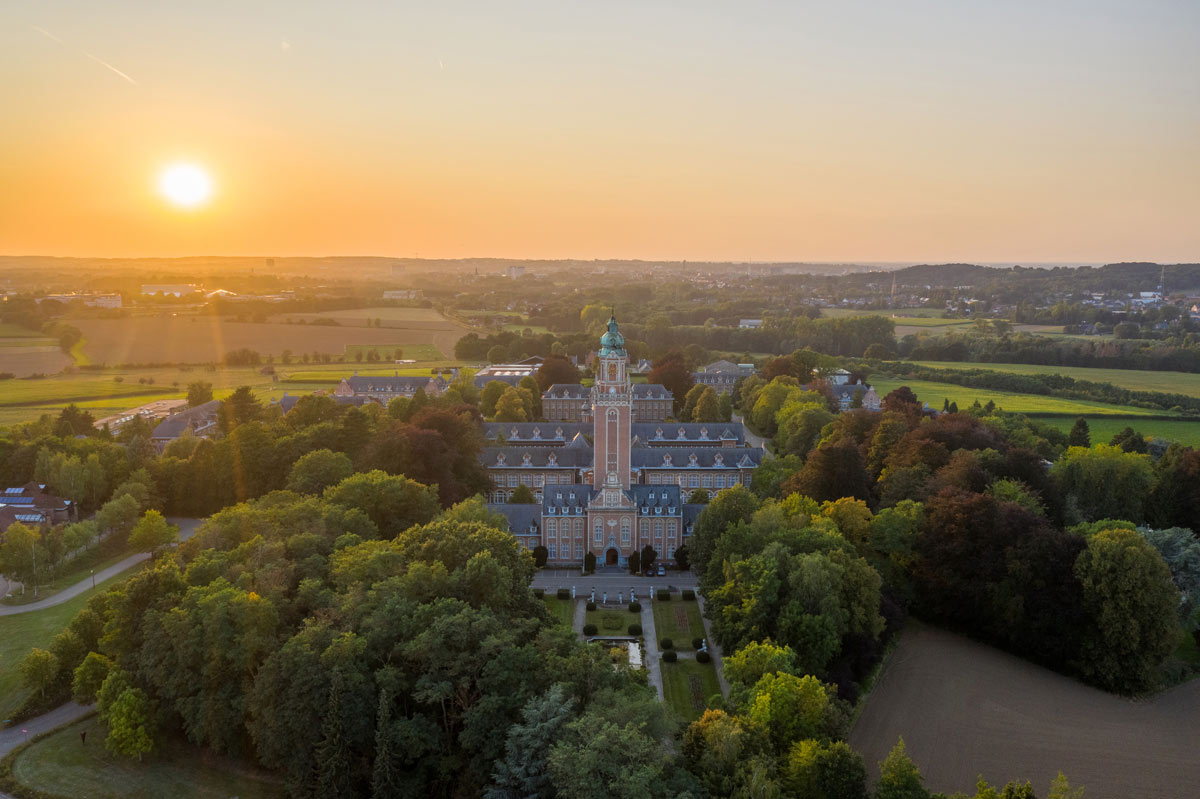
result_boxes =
[481,318,763,565]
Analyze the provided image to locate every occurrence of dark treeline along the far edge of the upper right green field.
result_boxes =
[896,334,1200,372]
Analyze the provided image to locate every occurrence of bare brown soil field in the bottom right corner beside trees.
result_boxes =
[850,623,1200,799]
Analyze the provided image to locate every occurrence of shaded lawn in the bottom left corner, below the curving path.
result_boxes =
[12,716,286,799]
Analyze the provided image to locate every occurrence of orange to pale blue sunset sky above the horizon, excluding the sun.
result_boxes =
[0,0,1200,263]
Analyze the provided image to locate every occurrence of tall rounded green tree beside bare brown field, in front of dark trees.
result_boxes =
[1075,529,1180,692]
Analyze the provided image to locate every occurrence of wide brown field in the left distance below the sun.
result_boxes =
[73,316,463,364]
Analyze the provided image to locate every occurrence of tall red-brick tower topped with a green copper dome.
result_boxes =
[592,316,634,489]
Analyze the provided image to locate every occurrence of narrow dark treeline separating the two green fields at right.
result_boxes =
[877,361,1200,414]
